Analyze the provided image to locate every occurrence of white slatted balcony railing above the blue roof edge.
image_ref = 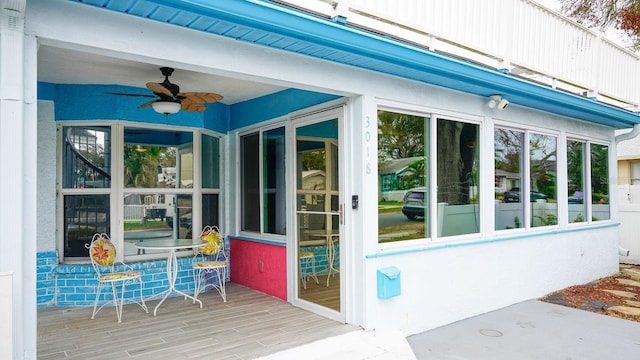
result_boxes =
[279,0,640,111]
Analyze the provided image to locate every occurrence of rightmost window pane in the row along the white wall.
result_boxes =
[591,144,610,221]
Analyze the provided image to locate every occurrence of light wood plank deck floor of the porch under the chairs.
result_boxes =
[38,283,359,360]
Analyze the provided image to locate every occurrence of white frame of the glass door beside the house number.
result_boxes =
[287,104,351,323]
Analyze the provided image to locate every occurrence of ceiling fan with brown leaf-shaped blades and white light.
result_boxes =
[107,67,222,115]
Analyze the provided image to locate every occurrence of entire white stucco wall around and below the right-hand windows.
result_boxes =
[350,90,619,335]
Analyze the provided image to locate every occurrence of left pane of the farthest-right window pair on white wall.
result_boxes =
[567,140,587,223]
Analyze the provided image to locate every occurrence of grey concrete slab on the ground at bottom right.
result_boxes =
[408,300,640,360]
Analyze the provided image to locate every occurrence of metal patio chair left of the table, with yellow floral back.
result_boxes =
[85,233,149,322]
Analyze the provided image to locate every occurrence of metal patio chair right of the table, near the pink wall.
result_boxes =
[191,226,229,302]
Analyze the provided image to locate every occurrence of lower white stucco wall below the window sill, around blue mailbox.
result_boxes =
[366,226,618,335]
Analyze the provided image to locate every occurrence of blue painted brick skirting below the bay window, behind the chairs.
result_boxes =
[36,251,230,308]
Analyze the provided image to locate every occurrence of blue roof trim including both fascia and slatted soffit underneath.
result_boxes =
[69,0,640,128]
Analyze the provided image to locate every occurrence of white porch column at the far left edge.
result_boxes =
[0,0,37,359]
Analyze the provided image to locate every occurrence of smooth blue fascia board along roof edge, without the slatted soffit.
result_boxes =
[140,0,640,128]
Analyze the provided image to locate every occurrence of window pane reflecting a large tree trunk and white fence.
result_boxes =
[437,119,480,236]
